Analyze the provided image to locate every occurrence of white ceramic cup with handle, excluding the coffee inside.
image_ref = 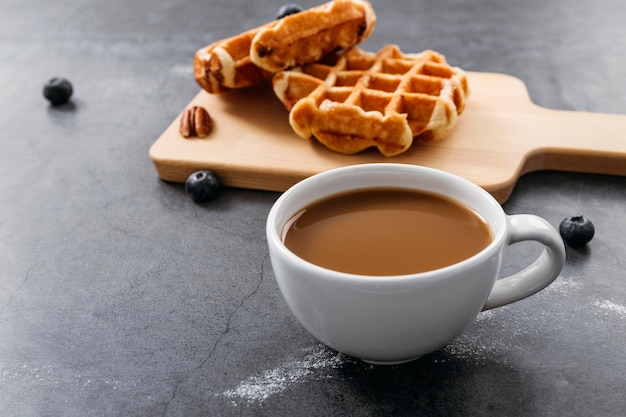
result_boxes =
[266,163,565,364]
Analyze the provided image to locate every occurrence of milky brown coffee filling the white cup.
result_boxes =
[283,188,492,276]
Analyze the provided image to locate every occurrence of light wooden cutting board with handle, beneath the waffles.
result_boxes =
[150,72,626,202]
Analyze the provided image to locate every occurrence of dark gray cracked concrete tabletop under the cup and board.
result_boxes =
[0,0,626,417]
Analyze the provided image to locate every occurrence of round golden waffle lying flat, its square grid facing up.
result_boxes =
[273,45,469,156]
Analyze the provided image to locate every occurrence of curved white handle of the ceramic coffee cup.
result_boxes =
[483,214,565,310]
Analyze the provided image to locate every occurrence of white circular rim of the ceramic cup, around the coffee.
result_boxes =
[266,162,506,283]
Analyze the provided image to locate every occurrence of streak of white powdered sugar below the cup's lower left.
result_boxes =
[220,345,347,404]
